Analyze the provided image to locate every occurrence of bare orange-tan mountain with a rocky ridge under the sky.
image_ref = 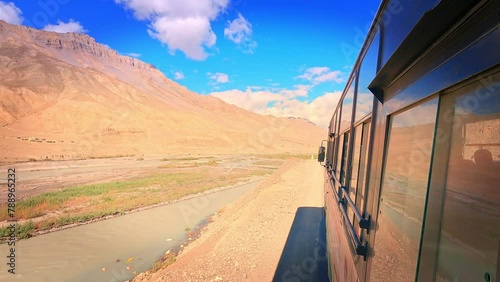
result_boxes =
[0,20,326,161]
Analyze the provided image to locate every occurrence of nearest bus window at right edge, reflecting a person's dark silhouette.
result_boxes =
[435,73,500,281]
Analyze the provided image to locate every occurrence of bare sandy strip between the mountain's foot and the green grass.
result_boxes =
[0,155,278,203]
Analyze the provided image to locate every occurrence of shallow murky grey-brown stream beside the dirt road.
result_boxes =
[0,181,261,282]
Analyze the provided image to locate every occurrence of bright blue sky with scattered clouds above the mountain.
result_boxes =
[0,0,379,125]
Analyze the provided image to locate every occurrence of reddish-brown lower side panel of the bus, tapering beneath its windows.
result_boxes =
[325,173,359,282]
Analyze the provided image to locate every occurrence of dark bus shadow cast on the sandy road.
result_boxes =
[273,207,328,282]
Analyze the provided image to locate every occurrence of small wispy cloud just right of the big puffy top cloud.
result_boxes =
[224,14,257,53]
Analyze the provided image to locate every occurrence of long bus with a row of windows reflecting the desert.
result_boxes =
[318,0,500,282]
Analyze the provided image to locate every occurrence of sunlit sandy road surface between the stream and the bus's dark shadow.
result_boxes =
[134,159,323,282]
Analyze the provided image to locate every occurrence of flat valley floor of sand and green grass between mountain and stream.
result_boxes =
[0,155,300,241]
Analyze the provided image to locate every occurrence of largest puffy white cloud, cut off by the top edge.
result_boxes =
[115,0,229,60]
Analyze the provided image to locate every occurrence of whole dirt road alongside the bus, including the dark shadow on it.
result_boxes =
[134,159,326,282]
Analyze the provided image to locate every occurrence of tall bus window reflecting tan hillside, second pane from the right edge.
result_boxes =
[370,98,437,281]
